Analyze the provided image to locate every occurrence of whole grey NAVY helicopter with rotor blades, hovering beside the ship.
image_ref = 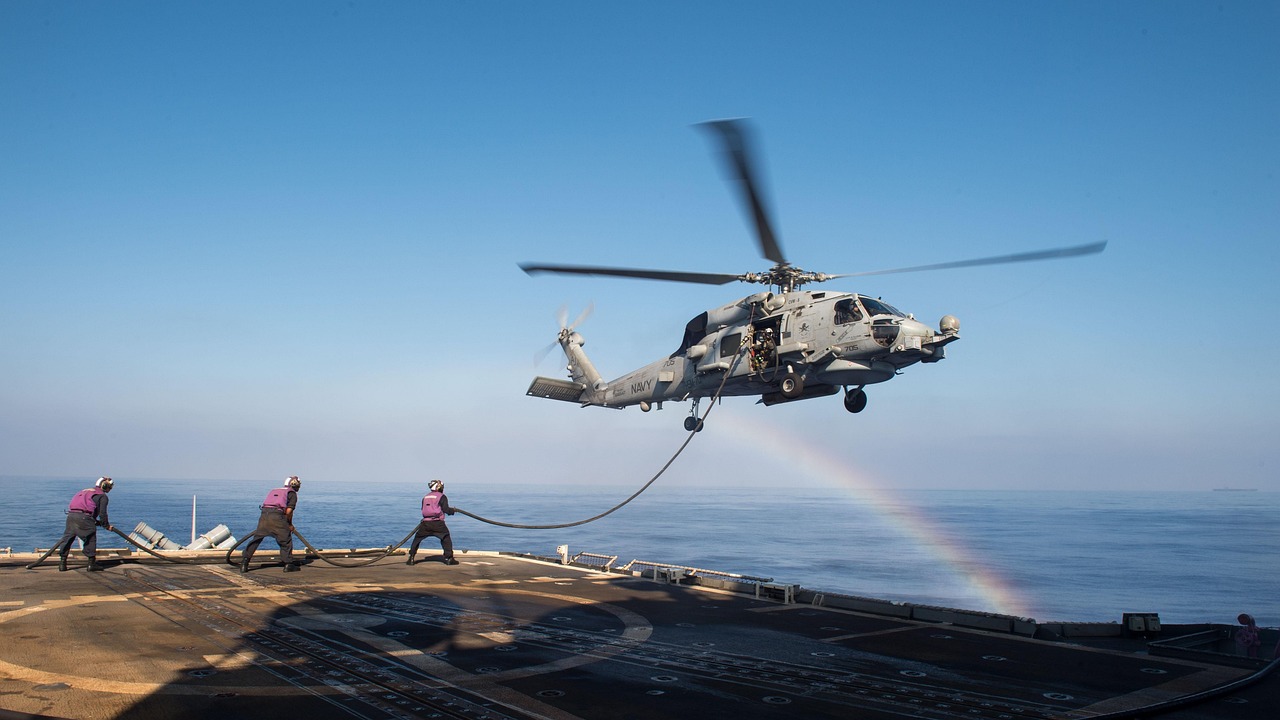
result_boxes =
[520,119,1106,432]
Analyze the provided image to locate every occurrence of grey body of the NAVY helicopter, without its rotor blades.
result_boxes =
[529,291,960,411]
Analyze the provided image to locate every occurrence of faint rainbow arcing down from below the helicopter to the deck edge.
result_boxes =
[708,413,1029,618]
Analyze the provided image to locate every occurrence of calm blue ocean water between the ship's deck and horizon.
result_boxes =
[0,477,1280,626]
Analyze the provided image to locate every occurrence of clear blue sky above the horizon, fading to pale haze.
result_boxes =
[0,1,1280,491]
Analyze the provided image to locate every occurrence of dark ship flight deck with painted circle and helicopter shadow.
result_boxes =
[0,552,1280,720]
